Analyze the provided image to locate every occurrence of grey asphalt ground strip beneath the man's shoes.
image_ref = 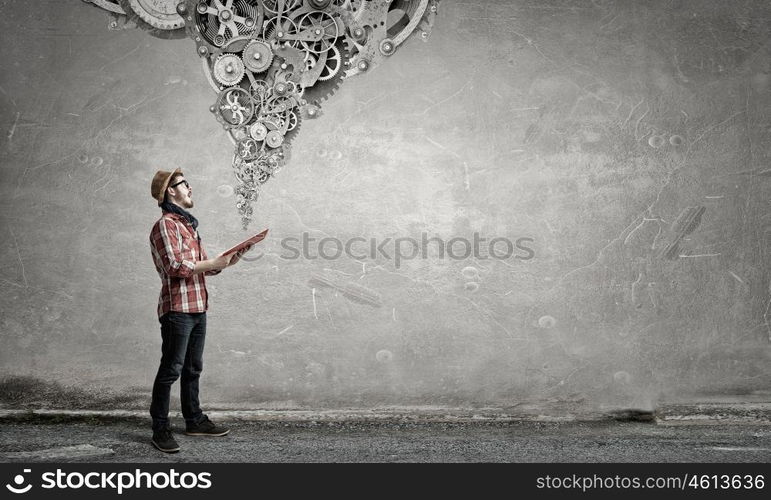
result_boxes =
[0,416,771,463]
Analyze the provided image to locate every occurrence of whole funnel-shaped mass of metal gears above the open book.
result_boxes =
[86,0,440,227]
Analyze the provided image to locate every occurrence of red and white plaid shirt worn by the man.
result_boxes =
[150,212,220,317]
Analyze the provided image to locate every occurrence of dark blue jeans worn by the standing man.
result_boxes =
[150,311,206,430]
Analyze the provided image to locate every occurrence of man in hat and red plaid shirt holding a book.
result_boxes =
[150,169,249,453]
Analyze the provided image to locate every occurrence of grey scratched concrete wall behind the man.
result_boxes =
[0,0,771,407]
